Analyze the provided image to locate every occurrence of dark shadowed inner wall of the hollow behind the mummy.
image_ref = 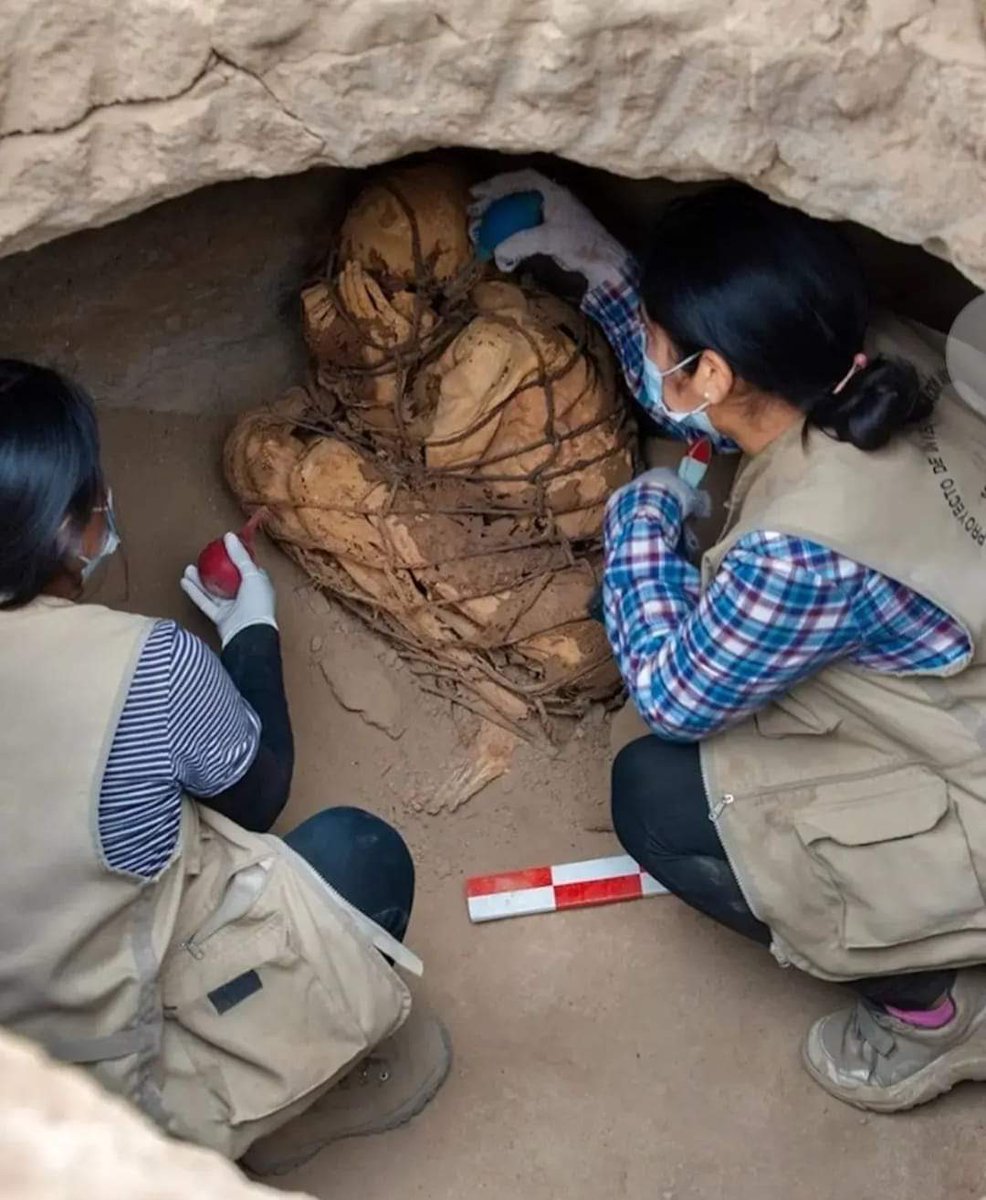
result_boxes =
[0,164,976,413]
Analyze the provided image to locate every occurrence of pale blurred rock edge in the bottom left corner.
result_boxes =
[0,1031,303,1200]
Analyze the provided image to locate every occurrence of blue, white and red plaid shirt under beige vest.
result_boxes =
[582,265,972,742]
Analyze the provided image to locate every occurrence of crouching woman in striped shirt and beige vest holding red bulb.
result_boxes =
[0,360,450,1166]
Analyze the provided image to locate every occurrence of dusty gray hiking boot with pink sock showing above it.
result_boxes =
[802,967,986,1112]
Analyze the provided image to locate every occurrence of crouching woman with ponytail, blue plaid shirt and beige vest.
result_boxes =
[476,173,986,1111]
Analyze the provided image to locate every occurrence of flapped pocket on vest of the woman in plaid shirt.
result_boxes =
[794,767,986,949]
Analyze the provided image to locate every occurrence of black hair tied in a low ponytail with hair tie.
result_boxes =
[641,184,933,450]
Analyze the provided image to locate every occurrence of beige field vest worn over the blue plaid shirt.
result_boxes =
[702,319,986,979]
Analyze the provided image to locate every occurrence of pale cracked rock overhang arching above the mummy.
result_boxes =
[0,0,986,283]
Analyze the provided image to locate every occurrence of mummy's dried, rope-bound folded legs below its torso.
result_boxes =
[227,413,617,715]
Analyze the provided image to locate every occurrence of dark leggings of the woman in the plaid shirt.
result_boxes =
[613,737,955,1009]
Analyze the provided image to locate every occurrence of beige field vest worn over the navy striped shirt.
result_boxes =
[0,600,420,1157]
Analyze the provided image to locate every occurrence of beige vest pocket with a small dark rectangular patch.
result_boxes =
[162,913,367,1126]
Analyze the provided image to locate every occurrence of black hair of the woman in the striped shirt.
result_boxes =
[0,359,103,608]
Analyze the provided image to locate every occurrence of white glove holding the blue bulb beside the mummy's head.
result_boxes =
[469,170,630,288]
